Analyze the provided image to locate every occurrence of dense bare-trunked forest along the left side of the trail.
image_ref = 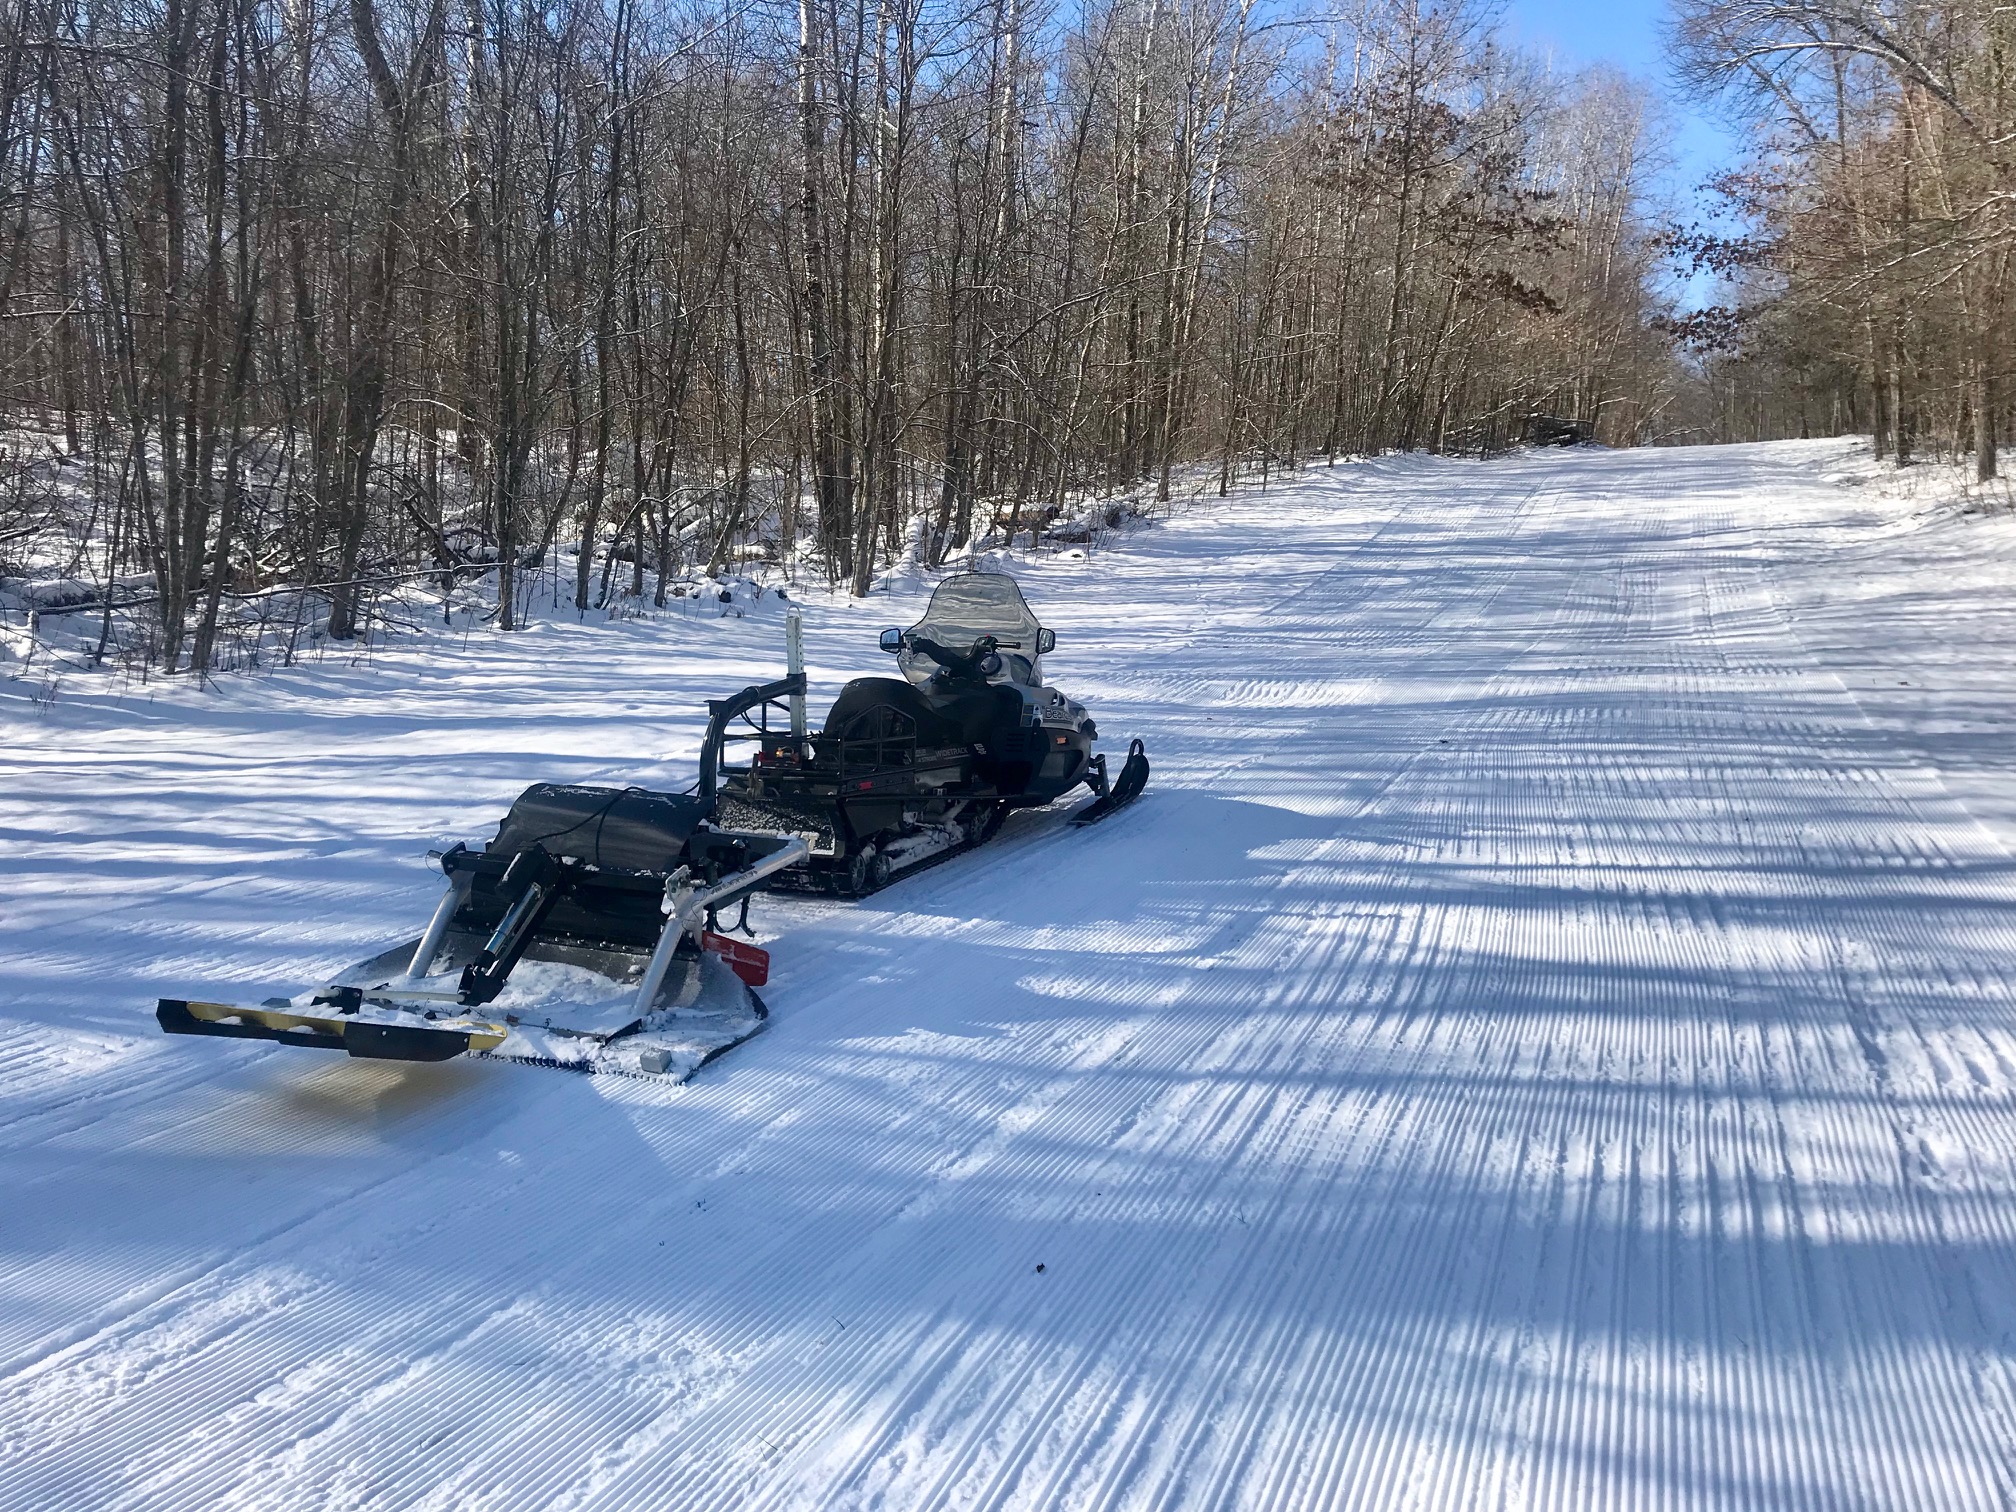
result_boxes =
[0,0,1669,669]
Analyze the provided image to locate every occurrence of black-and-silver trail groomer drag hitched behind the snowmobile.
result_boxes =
[155,671,808,1081]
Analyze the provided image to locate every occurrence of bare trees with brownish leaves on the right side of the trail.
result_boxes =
[1677,0,2016,482]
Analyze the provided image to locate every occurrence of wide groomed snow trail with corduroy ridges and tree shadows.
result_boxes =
[0,448,2016,1512]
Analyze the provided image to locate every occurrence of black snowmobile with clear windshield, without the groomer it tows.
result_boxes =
[720,573,1149,897]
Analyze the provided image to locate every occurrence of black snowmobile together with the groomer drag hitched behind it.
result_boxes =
[155,575,1149,1081]
